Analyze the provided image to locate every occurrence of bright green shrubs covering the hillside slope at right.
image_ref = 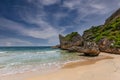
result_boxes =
[85,17,120,47]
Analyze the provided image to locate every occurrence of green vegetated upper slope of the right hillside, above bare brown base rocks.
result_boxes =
[83,9,120,47]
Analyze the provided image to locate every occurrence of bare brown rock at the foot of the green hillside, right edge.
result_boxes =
[98,38,120,54]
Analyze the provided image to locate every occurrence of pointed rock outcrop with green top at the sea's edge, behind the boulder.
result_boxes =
[59,32,83,49]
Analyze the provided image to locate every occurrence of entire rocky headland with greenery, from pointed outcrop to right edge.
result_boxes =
[59,9,120,56]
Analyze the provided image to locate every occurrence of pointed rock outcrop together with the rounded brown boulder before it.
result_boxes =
[59,32,100,56]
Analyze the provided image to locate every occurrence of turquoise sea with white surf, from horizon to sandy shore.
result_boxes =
[0,47,80,76]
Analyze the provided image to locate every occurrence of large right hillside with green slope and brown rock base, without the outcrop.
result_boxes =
[82,9,120,54]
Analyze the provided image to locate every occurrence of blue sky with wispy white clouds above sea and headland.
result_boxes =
[0,0,120,46]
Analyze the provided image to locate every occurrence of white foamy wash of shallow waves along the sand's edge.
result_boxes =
[0,62,61,76]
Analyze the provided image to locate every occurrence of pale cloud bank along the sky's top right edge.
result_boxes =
[63,0,120,14]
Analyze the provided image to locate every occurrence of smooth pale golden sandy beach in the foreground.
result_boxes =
[0,53,120,80]
